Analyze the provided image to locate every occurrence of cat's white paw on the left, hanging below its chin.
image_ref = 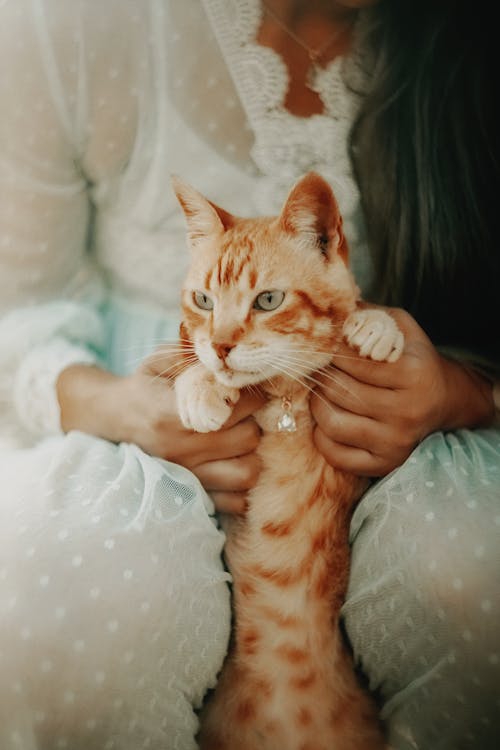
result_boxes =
[175,365,240,432]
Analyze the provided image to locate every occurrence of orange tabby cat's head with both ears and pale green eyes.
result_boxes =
[174,173,358,388]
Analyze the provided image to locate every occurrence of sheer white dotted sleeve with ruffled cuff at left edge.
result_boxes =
[0,0,104,444]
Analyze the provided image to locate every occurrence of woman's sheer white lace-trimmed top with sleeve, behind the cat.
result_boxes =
[0,0,369,440]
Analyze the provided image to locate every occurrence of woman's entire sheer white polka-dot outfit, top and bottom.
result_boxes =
[0,0,500,750]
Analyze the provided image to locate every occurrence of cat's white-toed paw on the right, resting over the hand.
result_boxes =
[343,309,404,362]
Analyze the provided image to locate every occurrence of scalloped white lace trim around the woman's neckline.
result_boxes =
[205,0,368,220]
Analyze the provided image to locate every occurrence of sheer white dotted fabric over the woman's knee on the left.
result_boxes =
[0,433,229,750]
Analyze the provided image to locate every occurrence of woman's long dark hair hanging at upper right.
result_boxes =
[351,0,500,369]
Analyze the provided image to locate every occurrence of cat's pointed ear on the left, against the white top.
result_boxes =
[171,175,234,245]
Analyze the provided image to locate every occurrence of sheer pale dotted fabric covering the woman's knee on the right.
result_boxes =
[343,429,500,750]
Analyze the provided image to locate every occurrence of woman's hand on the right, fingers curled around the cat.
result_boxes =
[311,308,494,477]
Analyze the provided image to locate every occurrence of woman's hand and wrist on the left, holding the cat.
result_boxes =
[57,347,264,513]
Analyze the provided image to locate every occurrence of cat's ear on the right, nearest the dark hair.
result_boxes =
[279,172,348,262]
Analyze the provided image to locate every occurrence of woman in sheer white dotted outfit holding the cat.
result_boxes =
[0,0,500,750]
